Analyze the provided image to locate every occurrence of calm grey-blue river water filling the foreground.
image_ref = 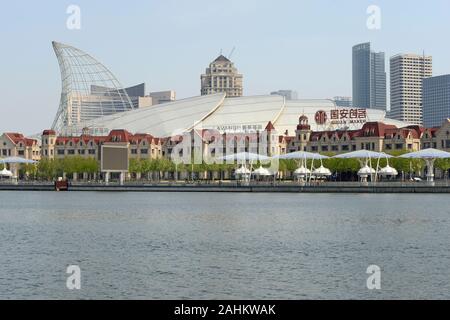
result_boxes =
[0,192,450,299]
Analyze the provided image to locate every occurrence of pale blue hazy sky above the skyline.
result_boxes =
[0,0,450,134]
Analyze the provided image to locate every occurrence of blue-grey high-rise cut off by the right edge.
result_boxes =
[423,74,450,128]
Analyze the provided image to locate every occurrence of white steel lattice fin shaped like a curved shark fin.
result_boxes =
[52,42,133,134]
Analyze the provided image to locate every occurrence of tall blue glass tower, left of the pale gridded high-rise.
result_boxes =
[352,42,386,110]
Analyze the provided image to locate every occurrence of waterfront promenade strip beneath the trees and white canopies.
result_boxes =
[0,180,450,193]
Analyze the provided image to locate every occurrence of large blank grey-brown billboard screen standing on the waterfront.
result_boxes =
[100,143,129,172]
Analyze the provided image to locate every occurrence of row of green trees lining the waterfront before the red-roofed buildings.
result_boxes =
[15,153,450,180]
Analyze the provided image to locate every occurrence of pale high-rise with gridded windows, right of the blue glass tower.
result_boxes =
[390,54,433,125]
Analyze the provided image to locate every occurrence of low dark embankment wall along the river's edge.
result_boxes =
[0,184,450,193]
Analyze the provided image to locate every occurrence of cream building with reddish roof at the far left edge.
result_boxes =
[0,133,41,161]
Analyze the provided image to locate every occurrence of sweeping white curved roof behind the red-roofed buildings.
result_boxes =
[81,93,407,137]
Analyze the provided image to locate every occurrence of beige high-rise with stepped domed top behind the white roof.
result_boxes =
[201,55,242,97]
